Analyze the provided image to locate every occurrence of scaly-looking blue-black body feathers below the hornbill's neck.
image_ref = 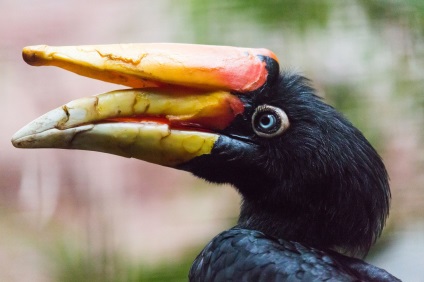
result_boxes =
[189,228,399,282]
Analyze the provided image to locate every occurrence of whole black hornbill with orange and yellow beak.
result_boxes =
[12,43,399,281]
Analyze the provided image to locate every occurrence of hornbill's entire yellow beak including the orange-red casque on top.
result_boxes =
[12,44,278,166]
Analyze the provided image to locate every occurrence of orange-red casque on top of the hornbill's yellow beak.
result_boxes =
[22,43,278,92]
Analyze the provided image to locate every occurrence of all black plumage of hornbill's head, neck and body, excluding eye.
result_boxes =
[180,73,398,281]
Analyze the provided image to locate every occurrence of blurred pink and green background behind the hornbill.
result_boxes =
[0,0,424,281]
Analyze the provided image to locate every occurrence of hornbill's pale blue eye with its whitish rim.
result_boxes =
[252,105,289,138]
